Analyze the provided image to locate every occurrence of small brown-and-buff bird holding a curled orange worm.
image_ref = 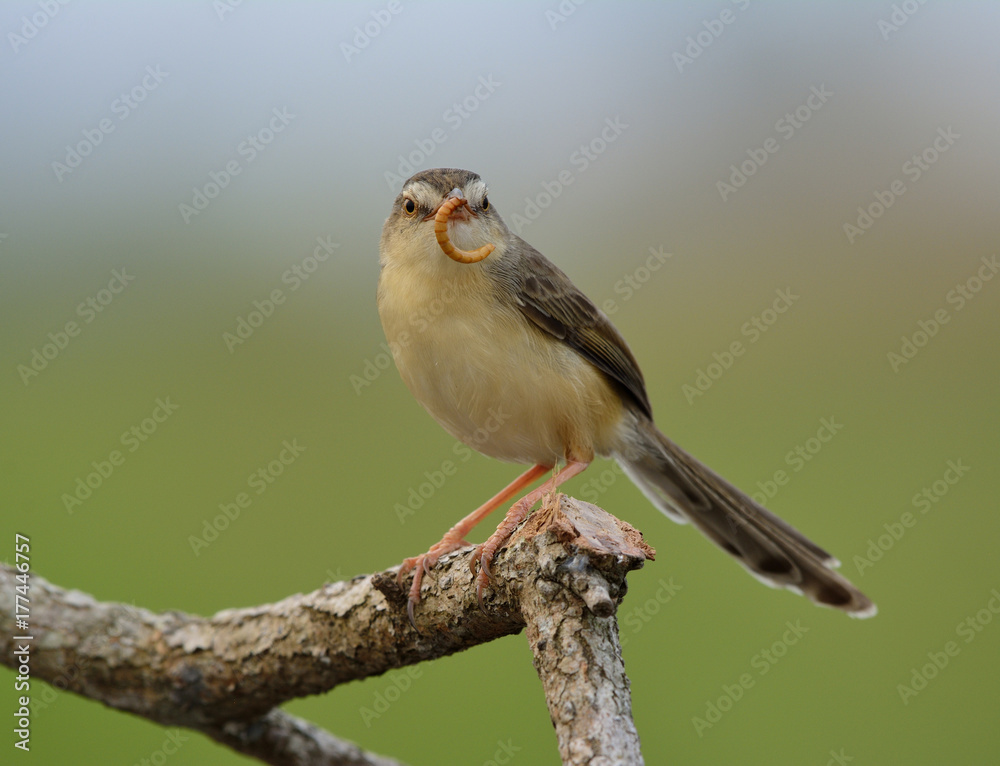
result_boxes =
[378,168,876,622]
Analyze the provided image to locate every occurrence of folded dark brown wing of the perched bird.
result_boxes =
[516,243,653,418]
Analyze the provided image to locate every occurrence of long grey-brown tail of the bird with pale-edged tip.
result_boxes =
[618,419,877,617]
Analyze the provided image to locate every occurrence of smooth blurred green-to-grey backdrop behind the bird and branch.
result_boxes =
[0,0,1000,766]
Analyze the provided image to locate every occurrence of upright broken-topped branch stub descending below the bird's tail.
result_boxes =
[508,497,653,766]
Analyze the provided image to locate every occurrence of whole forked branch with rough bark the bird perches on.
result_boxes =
[0,495,653,765]
